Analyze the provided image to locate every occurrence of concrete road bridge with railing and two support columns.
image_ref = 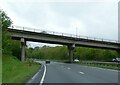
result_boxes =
[8,26,120,62]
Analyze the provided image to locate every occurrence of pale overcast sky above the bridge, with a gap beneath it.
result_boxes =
[0,0,119,47]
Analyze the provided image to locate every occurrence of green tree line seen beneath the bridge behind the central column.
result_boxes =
[26,46,118,61]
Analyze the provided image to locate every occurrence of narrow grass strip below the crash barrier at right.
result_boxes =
[78,62,120,70]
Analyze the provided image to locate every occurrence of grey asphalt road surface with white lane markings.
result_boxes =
[27,61,118,85]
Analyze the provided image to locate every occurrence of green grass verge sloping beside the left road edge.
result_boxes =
[2,55,40,83]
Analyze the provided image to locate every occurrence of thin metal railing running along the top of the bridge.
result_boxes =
[9,25,120,43]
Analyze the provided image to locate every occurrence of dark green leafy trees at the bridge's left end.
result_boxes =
[0,10,20,59]
